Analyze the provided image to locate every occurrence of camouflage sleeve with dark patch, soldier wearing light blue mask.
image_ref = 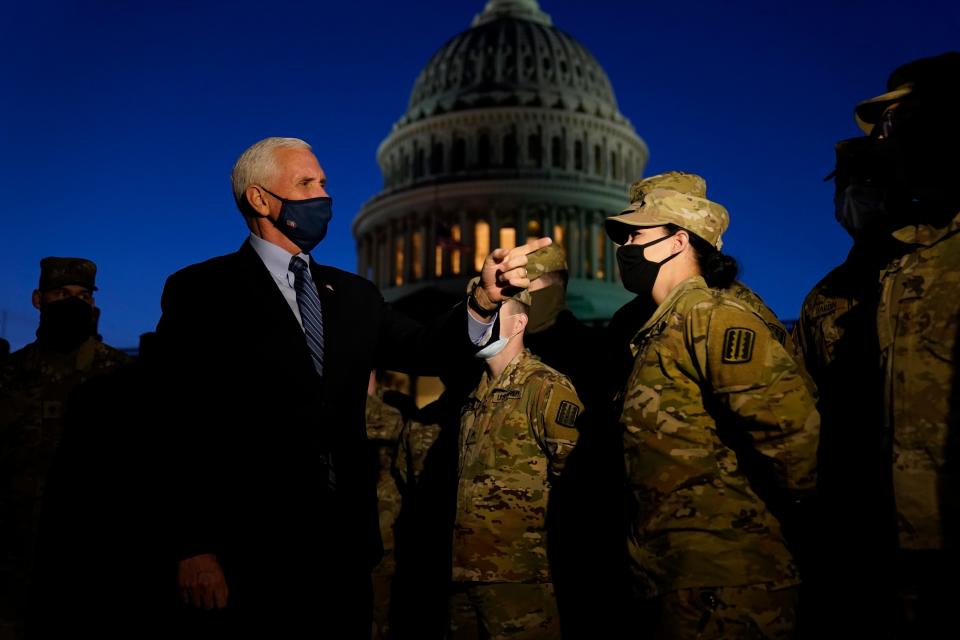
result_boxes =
[530,375,583,478]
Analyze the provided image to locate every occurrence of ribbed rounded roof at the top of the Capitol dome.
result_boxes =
[399,0,623,124]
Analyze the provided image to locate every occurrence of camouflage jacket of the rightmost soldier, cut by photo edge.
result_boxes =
[877,214,960,549]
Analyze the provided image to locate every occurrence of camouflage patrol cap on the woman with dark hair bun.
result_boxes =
[606,189,730,251]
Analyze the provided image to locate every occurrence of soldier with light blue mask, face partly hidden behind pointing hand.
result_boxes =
[450,292,583,639]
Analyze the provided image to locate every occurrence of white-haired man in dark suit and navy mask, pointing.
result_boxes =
[157,138,549,638]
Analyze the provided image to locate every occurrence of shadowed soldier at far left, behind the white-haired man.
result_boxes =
[0,257,130,638]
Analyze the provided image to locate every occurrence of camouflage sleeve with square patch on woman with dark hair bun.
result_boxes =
[687,304,820,492]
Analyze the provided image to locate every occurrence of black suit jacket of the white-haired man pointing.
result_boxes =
[157,242,475,599]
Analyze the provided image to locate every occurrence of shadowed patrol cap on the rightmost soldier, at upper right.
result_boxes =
[854,51,960,135]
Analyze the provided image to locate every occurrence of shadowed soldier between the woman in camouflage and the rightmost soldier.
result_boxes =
[791,122,908,636]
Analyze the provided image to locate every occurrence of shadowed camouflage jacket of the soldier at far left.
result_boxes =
[0,338,131,500]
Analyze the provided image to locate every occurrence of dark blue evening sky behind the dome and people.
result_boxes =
[0,0,960,348]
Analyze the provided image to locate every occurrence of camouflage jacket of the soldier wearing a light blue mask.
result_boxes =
[453,350,583,582]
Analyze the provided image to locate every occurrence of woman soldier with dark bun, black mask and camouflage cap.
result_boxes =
[606,188,819,638]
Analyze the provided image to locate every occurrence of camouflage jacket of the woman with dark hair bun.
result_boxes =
[621,276,819,597]
